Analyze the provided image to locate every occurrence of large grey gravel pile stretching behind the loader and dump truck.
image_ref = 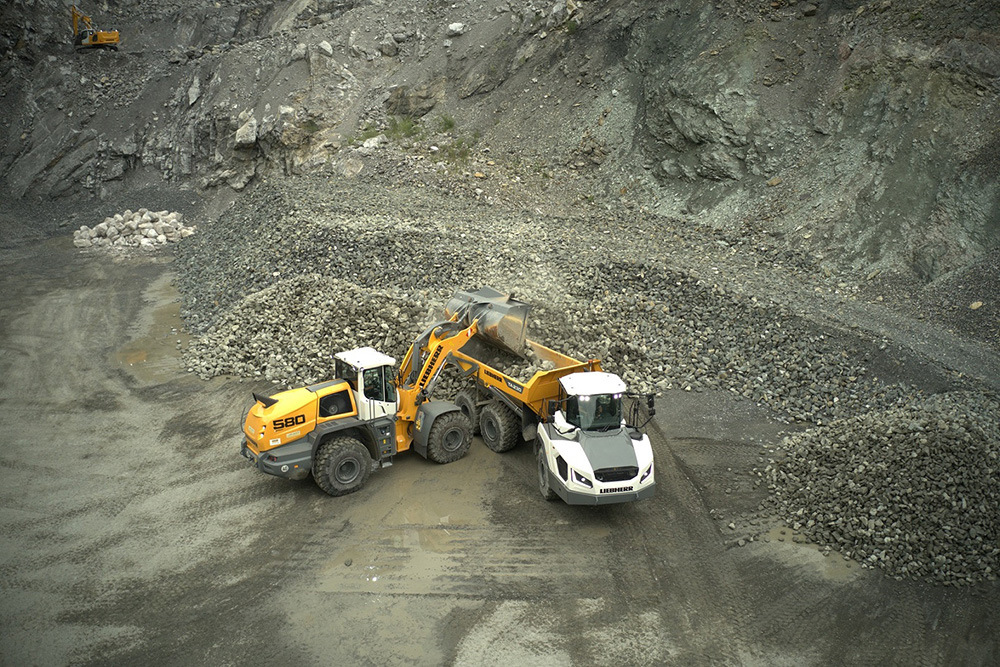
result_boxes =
[170,179,912,423]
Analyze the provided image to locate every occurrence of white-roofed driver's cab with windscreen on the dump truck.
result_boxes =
[556,371,625,432]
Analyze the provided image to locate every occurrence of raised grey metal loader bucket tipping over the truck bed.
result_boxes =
[444,287,531,357]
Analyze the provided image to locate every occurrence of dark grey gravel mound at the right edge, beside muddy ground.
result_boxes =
[763,392,1000,584]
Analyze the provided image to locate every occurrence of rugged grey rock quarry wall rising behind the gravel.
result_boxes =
[0,0,1000,280]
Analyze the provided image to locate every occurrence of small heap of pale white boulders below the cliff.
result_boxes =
[73,208,194,248]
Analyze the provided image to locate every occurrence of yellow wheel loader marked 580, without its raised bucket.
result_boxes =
[240,306,488,496]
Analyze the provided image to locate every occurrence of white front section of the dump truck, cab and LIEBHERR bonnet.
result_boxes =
[535,371,655,505]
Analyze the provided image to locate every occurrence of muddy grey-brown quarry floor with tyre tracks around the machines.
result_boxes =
[0,239,1000,667]
